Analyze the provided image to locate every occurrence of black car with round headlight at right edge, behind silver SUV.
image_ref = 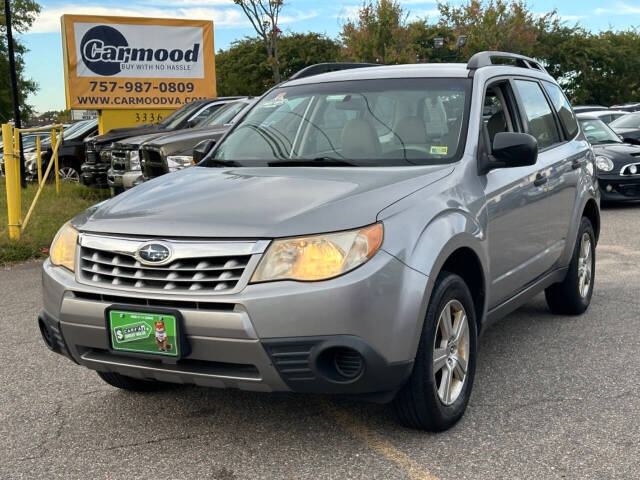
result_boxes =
[577,113,640,202]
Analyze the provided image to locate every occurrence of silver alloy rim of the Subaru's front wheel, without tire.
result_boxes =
[433,300,469,405]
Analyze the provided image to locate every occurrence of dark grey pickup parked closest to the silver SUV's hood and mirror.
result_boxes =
[140,98,255,180]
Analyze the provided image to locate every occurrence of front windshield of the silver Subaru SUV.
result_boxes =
[202,78,471,166]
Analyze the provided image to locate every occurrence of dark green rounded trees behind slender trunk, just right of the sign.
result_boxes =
[216,33,340,96]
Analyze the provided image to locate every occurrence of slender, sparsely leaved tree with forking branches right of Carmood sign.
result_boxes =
[233,0,284,83]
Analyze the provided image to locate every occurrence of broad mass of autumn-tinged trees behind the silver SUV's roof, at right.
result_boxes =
[340,0,640,105]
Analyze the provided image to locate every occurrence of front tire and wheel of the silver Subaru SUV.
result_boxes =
[392,272,477,432]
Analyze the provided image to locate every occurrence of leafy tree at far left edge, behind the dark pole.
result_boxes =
[0,0,40,122]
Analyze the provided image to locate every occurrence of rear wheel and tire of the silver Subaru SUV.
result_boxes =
[544,217,596,315]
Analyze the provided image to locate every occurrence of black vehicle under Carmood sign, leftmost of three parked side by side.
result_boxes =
[82,97,241,187]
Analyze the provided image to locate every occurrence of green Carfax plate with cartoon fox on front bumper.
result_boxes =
[109,310,180,357]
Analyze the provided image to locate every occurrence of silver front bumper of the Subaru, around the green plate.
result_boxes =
[41,251,430,399]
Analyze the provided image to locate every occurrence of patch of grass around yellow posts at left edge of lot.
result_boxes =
[0,181,109,267]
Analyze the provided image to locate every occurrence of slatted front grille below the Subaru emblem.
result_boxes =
[79,246,251,293]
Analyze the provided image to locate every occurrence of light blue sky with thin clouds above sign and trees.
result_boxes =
[13,0,640,112]
